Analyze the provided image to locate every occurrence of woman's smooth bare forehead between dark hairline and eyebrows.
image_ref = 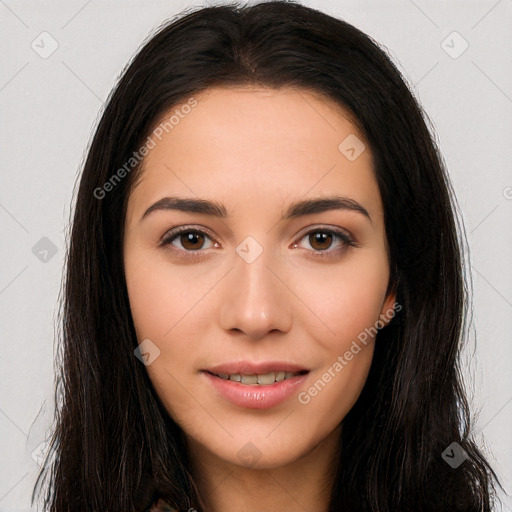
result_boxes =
[124,86,380,220]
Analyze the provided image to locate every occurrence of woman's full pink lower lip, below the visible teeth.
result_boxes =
[201,371,309,409]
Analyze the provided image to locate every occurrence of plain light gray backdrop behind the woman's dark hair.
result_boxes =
[0,0,512,512]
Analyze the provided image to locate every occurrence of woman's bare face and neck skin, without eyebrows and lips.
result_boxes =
[124,87,395,512]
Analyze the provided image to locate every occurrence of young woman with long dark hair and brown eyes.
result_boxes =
[33,1,504,512]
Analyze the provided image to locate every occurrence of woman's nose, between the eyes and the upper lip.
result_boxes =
[219,244,293,340]
